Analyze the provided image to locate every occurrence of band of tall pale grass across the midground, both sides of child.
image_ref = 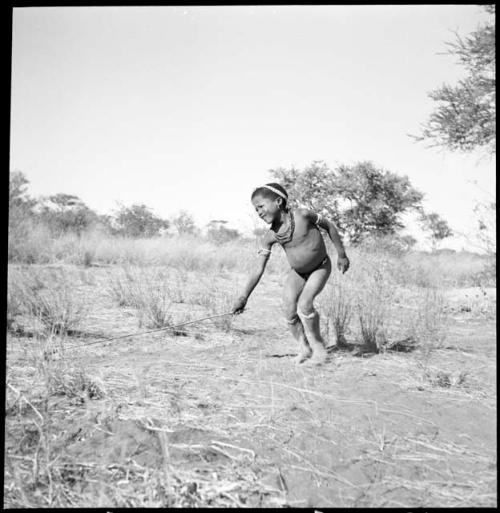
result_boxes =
[9,220,496,288]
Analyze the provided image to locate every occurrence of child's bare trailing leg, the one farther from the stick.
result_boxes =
[298,258,332,363]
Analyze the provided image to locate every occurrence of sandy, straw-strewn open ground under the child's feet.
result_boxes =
[4,269,497,508]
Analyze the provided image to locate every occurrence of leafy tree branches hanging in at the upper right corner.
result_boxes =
[412,5,496,154]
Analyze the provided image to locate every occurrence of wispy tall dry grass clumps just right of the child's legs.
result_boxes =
[319,246,446,353]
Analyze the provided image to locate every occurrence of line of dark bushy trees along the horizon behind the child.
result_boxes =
[9,161,452,249]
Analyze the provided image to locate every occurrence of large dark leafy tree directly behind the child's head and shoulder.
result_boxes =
[270,161,423,244]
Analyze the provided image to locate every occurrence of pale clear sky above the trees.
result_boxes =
[10,5,495,249]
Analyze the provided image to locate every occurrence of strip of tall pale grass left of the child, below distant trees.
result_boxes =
[9,223,284,274]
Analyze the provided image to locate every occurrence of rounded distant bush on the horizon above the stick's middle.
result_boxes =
[115,205,170,237]
